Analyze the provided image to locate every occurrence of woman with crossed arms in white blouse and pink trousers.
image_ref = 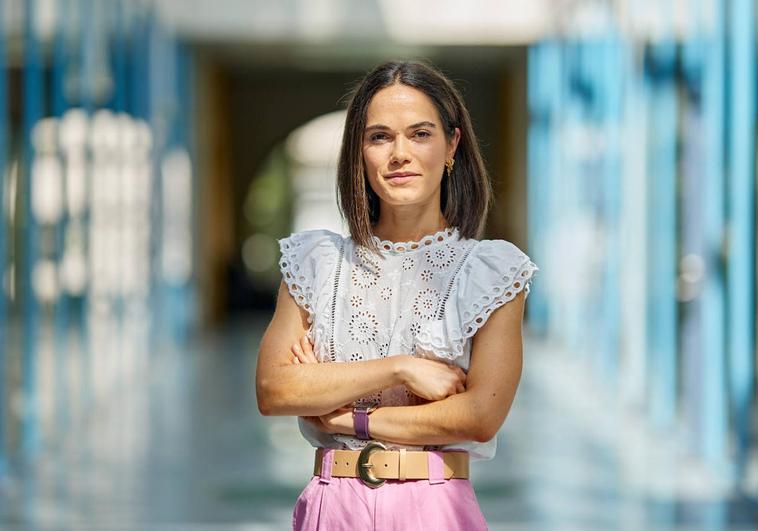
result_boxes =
[256,61,538,531]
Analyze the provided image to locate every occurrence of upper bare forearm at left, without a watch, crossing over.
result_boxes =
[256,355,406,416]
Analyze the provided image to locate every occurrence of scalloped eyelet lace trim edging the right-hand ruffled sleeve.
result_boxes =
[416,260,539,360]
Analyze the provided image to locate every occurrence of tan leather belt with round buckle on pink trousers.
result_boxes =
[313,441,469,486]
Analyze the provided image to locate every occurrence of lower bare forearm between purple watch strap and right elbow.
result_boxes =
[369,392,489,445]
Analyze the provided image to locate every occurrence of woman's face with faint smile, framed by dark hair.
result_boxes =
[363,84,460,213]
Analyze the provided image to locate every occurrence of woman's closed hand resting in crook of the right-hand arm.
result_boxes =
[401,356,466,401]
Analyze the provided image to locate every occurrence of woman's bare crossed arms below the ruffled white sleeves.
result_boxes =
[255,283,524,445]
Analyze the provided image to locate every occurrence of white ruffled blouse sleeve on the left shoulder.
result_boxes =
[277,229,342,324]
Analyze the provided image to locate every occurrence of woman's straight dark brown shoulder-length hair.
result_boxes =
[337,60,493,252]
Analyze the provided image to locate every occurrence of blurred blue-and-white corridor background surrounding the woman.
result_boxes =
[0,0,758,531]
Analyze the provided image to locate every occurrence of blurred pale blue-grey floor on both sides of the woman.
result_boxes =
[0,317,758,531]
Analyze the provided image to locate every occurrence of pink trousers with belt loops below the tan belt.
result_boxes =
[292,449,487,531]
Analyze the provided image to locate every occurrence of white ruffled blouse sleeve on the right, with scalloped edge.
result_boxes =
[415,240,539,365]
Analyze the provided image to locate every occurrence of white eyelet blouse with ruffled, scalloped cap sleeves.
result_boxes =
[278,227,539,461]
